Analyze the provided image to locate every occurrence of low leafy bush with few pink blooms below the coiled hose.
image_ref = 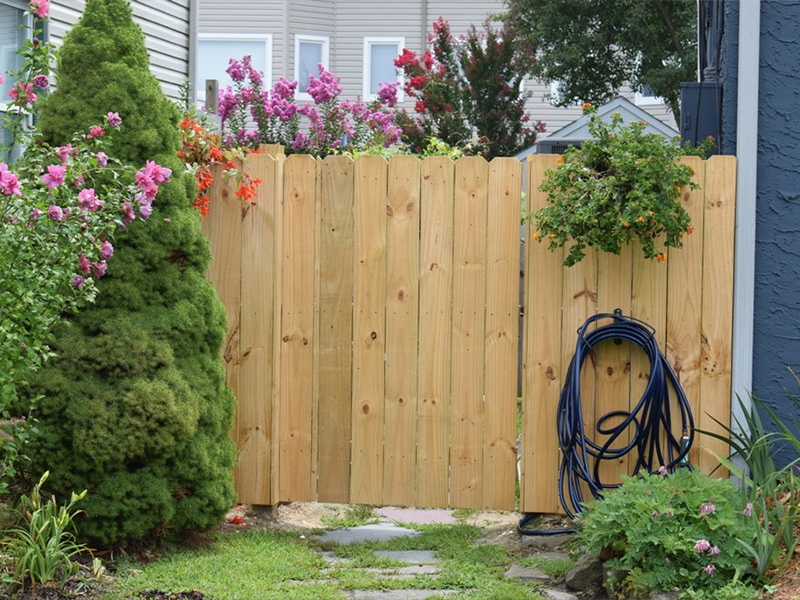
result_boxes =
[579,469,751,594]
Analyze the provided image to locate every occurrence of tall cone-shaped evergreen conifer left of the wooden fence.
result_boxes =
[29,0,236,544]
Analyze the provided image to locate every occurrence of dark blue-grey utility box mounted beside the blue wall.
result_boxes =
[681,81,722,154]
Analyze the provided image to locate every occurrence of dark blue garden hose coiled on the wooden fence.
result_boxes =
[517,311,694,535]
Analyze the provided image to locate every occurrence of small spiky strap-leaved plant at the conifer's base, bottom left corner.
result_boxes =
[3,472,87,589]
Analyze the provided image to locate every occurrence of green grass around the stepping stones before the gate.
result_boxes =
[102,524,541,600]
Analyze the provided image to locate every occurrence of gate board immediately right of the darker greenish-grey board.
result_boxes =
[350,156,388,504]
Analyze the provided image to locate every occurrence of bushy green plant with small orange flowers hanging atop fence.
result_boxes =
[533,104,711,266]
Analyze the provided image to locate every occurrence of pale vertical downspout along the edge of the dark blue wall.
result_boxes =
[731,0,761,458]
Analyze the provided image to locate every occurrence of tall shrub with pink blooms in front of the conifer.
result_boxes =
[0,0,171,464]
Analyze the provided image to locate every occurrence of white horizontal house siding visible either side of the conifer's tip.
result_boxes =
[50,0,190,100]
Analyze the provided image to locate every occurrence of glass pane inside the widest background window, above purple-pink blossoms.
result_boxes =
[196,40,270,102]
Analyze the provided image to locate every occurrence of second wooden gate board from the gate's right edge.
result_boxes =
[450,157,489,508]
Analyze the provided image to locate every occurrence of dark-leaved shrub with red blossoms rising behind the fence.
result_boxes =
[395,17,544,158]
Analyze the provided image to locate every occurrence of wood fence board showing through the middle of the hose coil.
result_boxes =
[591,251,633,484]
